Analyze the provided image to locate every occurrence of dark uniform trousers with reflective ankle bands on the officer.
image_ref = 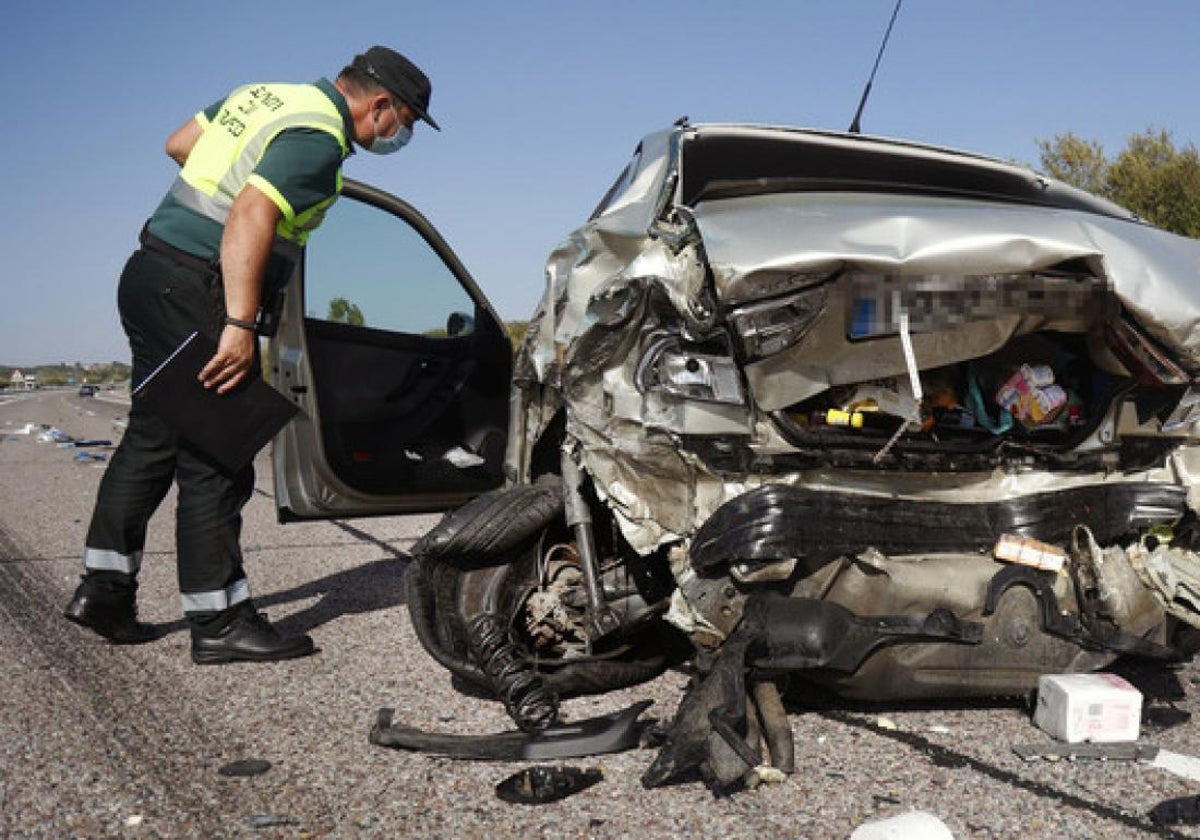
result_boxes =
[84,250,257,620]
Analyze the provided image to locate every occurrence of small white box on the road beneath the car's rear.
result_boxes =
[1033,673,1141,744]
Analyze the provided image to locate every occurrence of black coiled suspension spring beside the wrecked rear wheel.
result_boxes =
[467,612,558,732]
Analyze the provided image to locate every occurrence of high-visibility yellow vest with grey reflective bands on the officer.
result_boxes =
[170,83,349,245]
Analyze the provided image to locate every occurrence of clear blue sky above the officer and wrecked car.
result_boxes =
[0,0,1200,365]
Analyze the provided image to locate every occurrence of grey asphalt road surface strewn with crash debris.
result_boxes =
[7,391,1200,839]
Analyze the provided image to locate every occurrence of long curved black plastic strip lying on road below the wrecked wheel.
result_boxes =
[368,700,656,761]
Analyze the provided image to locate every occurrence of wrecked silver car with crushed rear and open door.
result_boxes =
[276,122,1200,785]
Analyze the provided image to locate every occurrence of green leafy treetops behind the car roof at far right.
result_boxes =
[1038,130,1200,238]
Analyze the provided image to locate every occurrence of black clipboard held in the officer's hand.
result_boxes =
[133,332,299,472]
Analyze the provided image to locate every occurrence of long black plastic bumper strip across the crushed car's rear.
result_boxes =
[691,484,1187,574]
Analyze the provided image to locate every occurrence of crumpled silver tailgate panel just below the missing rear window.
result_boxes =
[694,192,1200,365]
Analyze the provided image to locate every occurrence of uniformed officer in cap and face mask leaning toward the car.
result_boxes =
[65,47,438,664]
